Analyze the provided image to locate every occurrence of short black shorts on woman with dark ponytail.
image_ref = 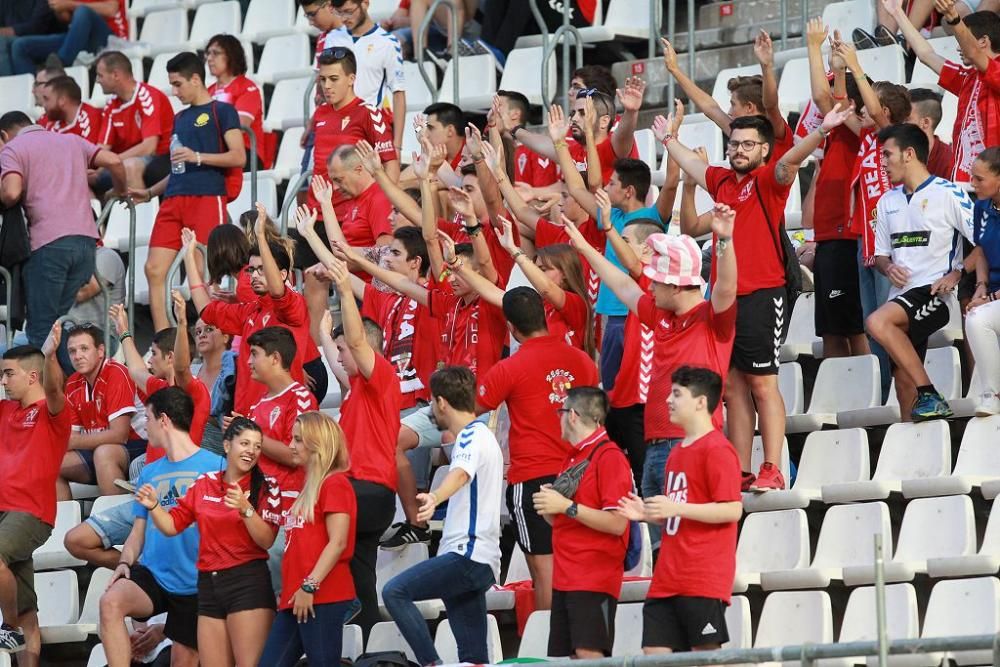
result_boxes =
[198,559,277,618]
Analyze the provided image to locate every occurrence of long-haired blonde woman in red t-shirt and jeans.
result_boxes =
[260,412,357,667]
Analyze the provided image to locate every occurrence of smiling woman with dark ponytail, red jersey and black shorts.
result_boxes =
[136,417,281,667]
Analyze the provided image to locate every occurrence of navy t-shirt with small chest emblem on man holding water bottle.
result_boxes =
[164,102,240,197]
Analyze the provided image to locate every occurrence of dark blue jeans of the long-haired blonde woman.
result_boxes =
[258,600,351,667]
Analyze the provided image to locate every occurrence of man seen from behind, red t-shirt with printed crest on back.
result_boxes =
[476,287,597,609]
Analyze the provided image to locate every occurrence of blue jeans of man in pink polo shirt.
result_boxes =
[24,236,97,347]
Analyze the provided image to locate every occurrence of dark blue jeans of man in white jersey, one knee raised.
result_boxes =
[382,553,496,665]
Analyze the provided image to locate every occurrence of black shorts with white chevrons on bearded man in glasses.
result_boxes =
[730,287,791,375]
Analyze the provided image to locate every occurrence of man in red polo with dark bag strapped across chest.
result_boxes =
[532,387,634,659]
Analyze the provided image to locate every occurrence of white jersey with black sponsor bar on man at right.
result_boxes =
[875,176,972,299]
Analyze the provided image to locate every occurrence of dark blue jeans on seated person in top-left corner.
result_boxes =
[10,7,111,74]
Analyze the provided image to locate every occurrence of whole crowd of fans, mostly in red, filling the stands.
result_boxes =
[0,0,1000,667]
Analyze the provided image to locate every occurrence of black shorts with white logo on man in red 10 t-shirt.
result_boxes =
[642,595,729,652]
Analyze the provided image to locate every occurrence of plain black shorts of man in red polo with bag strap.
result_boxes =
[549,589,618,657]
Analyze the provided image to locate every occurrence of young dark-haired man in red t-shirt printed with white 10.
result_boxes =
[619,366,743,655]
